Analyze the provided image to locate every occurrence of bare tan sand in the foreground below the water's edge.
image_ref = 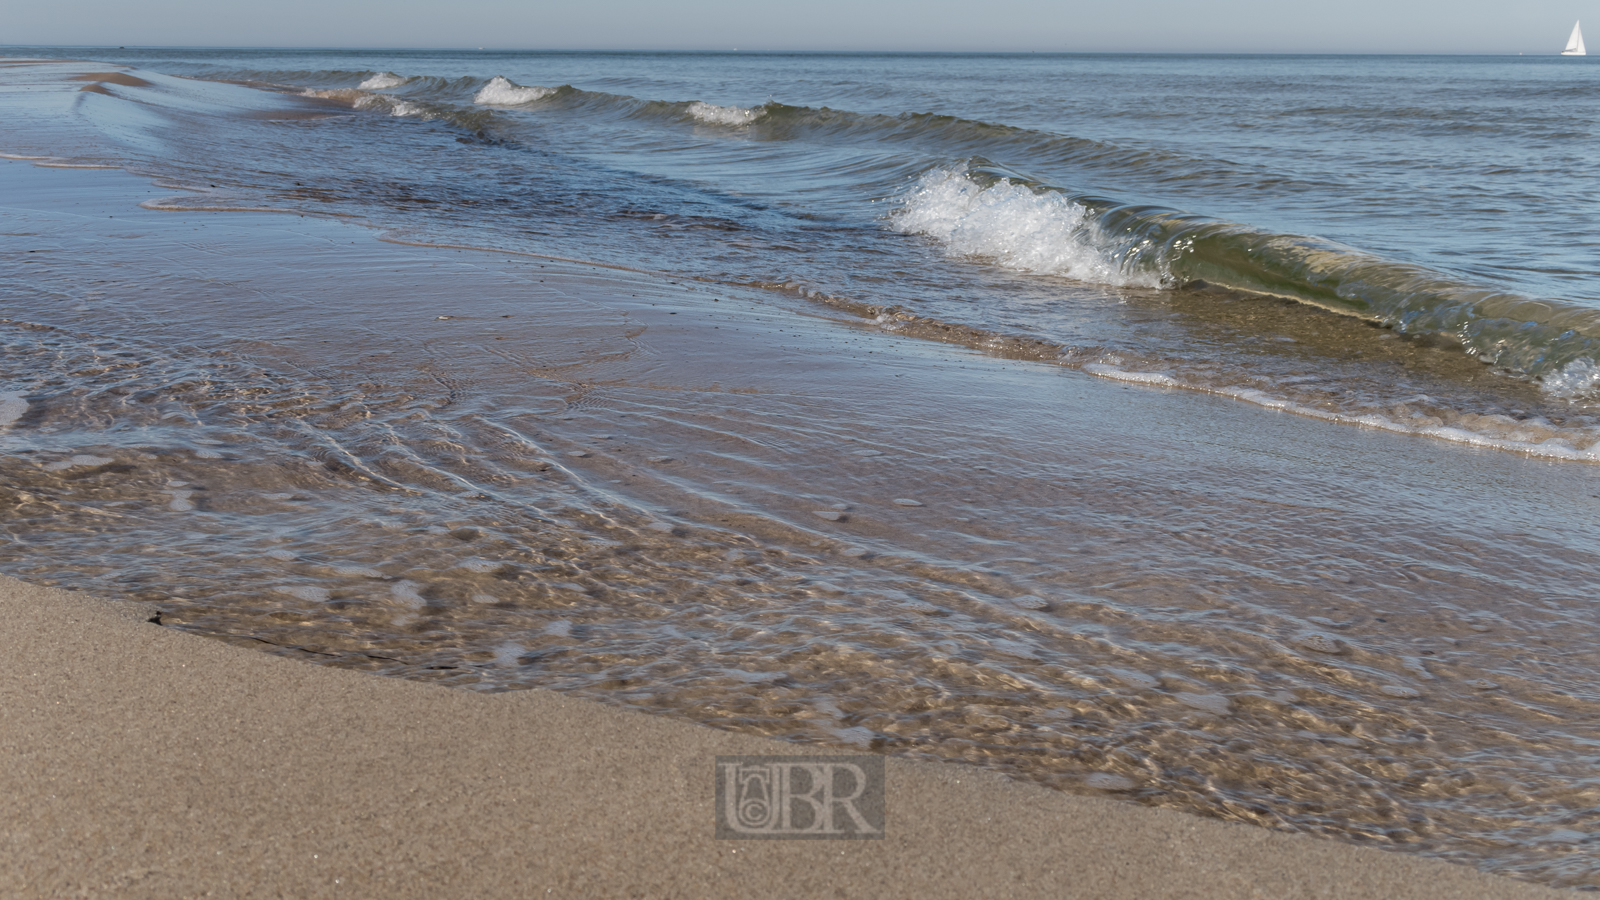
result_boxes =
[0,578,1563,900]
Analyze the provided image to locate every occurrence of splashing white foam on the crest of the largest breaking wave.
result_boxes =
[890,170,1160,287]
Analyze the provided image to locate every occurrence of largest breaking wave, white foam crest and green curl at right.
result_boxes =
[888,160,1600,395]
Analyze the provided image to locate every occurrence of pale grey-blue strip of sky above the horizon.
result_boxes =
[0,0,1600,53]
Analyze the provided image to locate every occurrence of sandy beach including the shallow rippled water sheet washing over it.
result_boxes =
[0,66,1595,898]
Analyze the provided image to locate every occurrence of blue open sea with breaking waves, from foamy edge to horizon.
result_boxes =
[18,51,1600,448]
